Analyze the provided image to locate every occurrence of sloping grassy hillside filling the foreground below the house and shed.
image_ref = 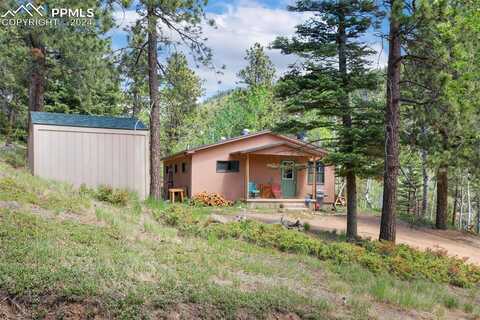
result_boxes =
[0,143,480,319]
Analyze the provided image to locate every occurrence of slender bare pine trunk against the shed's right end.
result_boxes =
[147,6,161,199]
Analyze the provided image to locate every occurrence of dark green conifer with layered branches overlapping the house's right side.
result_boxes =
[273,0,383,240]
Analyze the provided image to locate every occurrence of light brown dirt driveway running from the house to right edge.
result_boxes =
[242,213,480,265]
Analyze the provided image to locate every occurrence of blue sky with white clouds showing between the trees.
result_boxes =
[112,0,387,98]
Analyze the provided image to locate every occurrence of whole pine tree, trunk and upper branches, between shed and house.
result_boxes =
[135,0,213,199]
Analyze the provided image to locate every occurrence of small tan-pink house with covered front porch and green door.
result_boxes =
[163,131,335,208]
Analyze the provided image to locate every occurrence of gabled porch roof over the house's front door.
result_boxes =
[231,141,325,156]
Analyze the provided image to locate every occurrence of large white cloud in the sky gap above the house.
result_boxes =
[199,1,307,95]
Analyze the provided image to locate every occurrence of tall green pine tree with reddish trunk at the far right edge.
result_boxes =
[402,1,480,229]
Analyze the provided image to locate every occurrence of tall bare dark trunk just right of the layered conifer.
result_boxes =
[379,0,403,242]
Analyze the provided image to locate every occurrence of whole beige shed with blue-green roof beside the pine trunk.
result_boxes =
[28,112,149,199]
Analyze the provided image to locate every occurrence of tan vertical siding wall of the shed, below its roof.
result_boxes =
[33,125,148,199]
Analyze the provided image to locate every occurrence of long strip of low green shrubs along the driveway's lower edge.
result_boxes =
[156,205,480,287]
